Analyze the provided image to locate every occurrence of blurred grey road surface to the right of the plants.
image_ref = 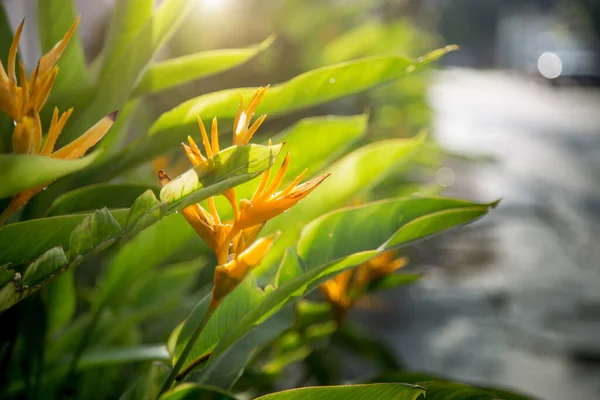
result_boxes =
[363,70,600,400]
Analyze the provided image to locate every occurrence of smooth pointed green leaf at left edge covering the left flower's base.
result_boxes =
[0,153,98,198]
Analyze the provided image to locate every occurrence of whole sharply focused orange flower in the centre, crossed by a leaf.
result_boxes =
[158,87,328,302]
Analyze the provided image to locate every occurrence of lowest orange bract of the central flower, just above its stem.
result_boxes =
[211,233,279,304]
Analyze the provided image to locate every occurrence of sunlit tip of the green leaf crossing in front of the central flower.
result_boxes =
[160,144,282,210]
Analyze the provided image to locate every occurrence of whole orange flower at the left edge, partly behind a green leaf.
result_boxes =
[0,18,117,226]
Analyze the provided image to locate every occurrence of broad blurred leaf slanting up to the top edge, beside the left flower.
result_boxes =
[60,0,196,143]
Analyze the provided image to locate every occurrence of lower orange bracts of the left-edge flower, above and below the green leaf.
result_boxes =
[0,112,118,226]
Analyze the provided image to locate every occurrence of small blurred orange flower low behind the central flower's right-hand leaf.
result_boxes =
[321,250,408,323]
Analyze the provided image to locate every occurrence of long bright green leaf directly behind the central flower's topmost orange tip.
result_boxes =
[107,47,452,169]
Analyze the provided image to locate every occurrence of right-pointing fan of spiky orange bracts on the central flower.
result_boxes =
[236,153,330,229]
